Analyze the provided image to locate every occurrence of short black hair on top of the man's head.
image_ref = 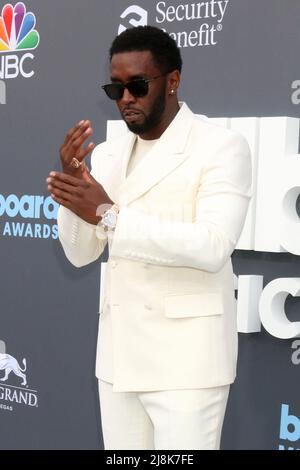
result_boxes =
[109,26,182,73]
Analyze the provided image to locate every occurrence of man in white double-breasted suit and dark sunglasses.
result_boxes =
[47,26,251,449]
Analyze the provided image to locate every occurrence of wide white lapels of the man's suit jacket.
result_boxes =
[115,103,194,205]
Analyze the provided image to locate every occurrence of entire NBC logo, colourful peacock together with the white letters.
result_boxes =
[0,2,40,80]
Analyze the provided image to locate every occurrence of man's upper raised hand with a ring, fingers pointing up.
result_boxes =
[59,121,95,179]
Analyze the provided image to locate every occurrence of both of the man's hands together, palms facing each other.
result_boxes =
[46,121,114,225]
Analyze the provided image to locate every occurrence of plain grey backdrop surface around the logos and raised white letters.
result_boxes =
[0,0,300,449]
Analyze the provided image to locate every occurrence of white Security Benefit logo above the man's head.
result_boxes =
[118,0,229,47]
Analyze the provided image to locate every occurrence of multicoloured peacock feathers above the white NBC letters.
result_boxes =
[0,2,40,53]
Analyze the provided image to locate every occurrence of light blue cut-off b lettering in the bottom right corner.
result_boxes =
[279,404,300,450]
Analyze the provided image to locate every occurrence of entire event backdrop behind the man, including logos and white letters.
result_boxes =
[0,0,300,450]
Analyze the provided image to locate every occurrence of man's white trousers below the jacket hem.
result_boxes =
[99,380,230,450]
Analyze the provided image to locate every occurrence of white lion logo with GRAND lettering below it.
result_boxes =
[0,340,38,411]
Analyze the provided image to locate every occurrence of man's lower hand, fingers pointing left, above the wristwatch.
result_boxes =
[47,171,114,225]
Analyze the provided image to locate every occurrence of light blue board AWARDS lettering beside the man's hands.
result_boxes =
[0,194,59,240]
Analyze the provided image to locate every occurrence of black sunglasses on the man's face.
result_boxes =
[101,72,170,100]
